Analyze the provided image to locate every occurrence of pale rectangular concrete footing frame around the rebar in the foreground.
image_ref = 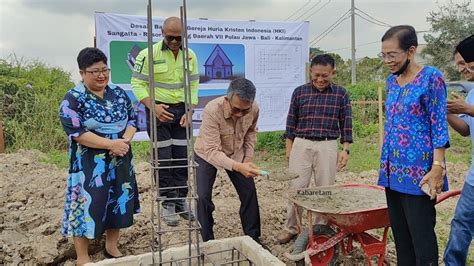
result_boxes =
[86,236,285,266]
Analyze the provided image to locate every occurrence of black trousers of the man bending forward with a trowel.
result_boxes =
[195,155,260,241]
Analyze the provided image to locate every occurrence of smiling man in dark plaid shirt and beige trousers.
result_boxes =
[277,54,352,244]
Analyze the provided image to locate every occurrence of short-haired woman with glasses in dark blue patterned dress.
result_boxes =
[59,48,140,264]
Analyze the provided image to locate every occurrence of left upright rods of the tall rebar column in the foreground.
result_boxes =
[147,0,162,265]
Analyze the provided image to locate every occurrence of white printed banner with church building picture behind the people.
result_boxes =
[95,13,309,138]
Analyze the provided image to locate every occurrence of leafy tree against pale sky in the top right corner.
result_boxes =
[421,0,474,80]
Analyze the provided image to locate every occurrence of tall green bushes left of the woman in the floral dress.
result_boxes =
[0,56,74,152]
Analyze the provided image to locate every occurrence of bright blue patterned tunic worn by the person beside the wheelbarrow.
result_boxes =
[378,66,449,195]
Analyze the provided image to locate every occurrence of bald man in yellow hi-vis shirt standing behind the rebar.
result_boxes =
[131,17,199,226]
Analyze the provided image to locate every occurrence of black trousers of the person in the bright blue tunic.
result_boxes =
[385,188,438,266]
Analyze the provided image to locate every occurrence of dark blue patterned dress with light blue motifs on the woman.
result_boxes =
[59,84,140,239]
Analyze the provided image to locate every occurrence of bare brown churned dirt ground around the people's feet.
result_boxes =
[0,151,467,265]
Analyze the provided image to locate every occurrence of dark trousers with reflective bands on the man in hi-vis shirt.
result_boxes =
[146,103,188,204]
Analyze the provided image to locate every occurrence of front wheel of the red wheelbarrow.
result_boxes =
[293,224,339,266]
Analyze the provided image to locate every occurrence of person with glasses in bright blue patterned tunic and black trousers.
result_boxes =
[378,25,449,265]
